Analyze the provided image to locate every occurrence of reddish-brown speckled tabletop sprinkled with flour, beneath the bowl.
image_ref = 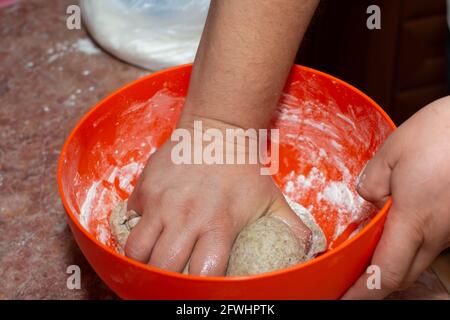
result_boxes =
[0,0,450,299]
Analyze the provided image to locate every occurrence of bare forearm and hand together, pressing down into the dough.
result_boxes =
[125,0,318,275]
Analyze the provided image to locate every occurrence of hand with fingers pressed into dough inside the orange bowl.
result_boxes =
[125,119,311,276]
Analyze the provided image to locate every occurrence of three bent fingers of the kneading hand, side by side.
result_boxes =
[125,182,234,276]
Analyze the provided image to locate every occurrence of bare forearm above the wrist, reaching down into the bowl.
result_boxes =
[183,0,319,128]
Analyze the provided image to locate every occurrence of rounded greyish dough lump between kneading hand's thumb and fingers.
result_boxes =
[227,216,306,276]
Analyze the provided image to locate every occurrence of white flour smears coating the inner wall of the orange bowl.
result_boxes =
[75,76,391,254]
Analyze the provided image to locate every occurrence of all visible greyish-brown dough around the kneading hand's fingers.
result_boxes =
[109,201,308,276]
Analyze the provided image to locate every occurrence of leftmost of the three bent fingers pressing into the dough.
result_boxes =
[125,212,163,263]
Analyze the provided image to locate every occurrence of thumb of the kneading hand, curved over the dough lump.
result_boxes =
[270,195,312,252]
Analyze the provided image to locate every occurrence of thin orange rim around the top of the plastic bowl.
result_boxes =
[57,63,397,283]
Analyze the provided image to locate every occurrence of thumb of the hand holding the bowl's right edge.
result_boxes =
[356,140,395,208]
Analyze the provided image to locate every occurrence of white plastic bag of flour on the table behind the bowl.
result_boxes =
[80,0,210,70]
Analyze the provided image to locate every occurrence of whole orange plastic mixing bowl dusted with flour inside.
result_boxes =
[58,65,395,299]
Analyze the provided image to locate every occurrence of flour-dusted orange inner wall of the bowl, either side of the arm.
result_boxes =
[60,66,394,260]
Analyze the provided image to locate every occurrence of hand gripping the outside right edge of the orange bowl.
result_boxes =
[343,96,450,299]
